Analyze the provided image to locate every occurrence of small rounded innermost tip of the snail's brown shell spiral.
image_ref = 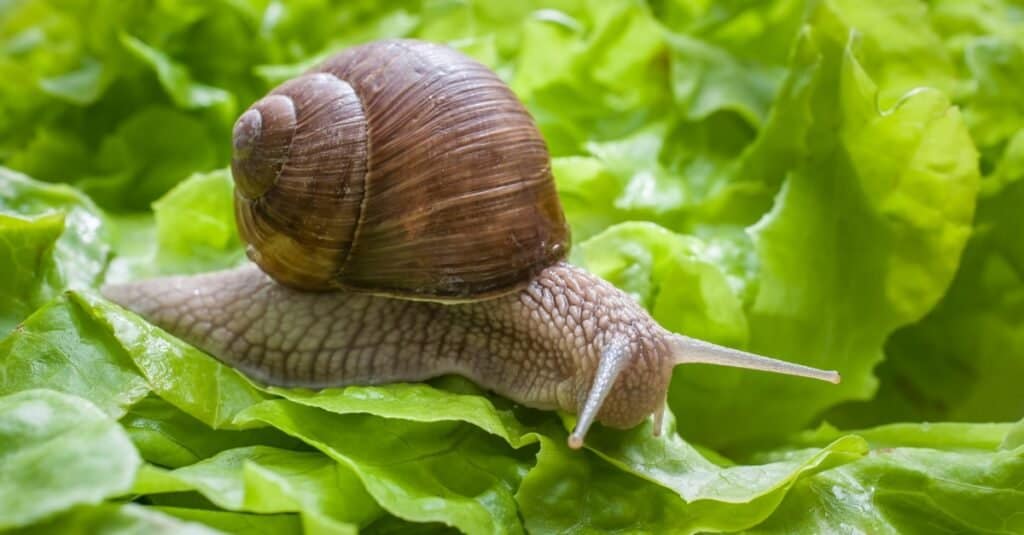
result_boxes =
[231,94,296,200]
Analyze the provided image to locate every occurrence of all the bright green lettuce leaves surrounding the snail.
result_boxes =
[0,0,1024,533]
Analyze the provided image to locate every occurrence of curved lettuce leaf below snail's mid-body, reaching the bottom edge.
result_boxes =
[234,401,527,533]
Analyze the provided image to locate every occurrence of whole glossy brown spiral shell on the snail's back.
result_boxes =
[231,40,568,300]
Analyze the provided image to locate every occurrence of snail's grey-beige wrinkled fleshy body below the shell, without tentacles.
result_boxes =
[103,262,675,428]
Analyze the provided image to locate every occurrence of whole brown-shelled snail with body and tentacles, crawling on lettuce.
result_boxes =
[103,40,839,448]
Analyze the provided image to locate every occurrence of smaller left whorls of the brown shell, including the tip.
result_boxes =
[231,73,367,290]
